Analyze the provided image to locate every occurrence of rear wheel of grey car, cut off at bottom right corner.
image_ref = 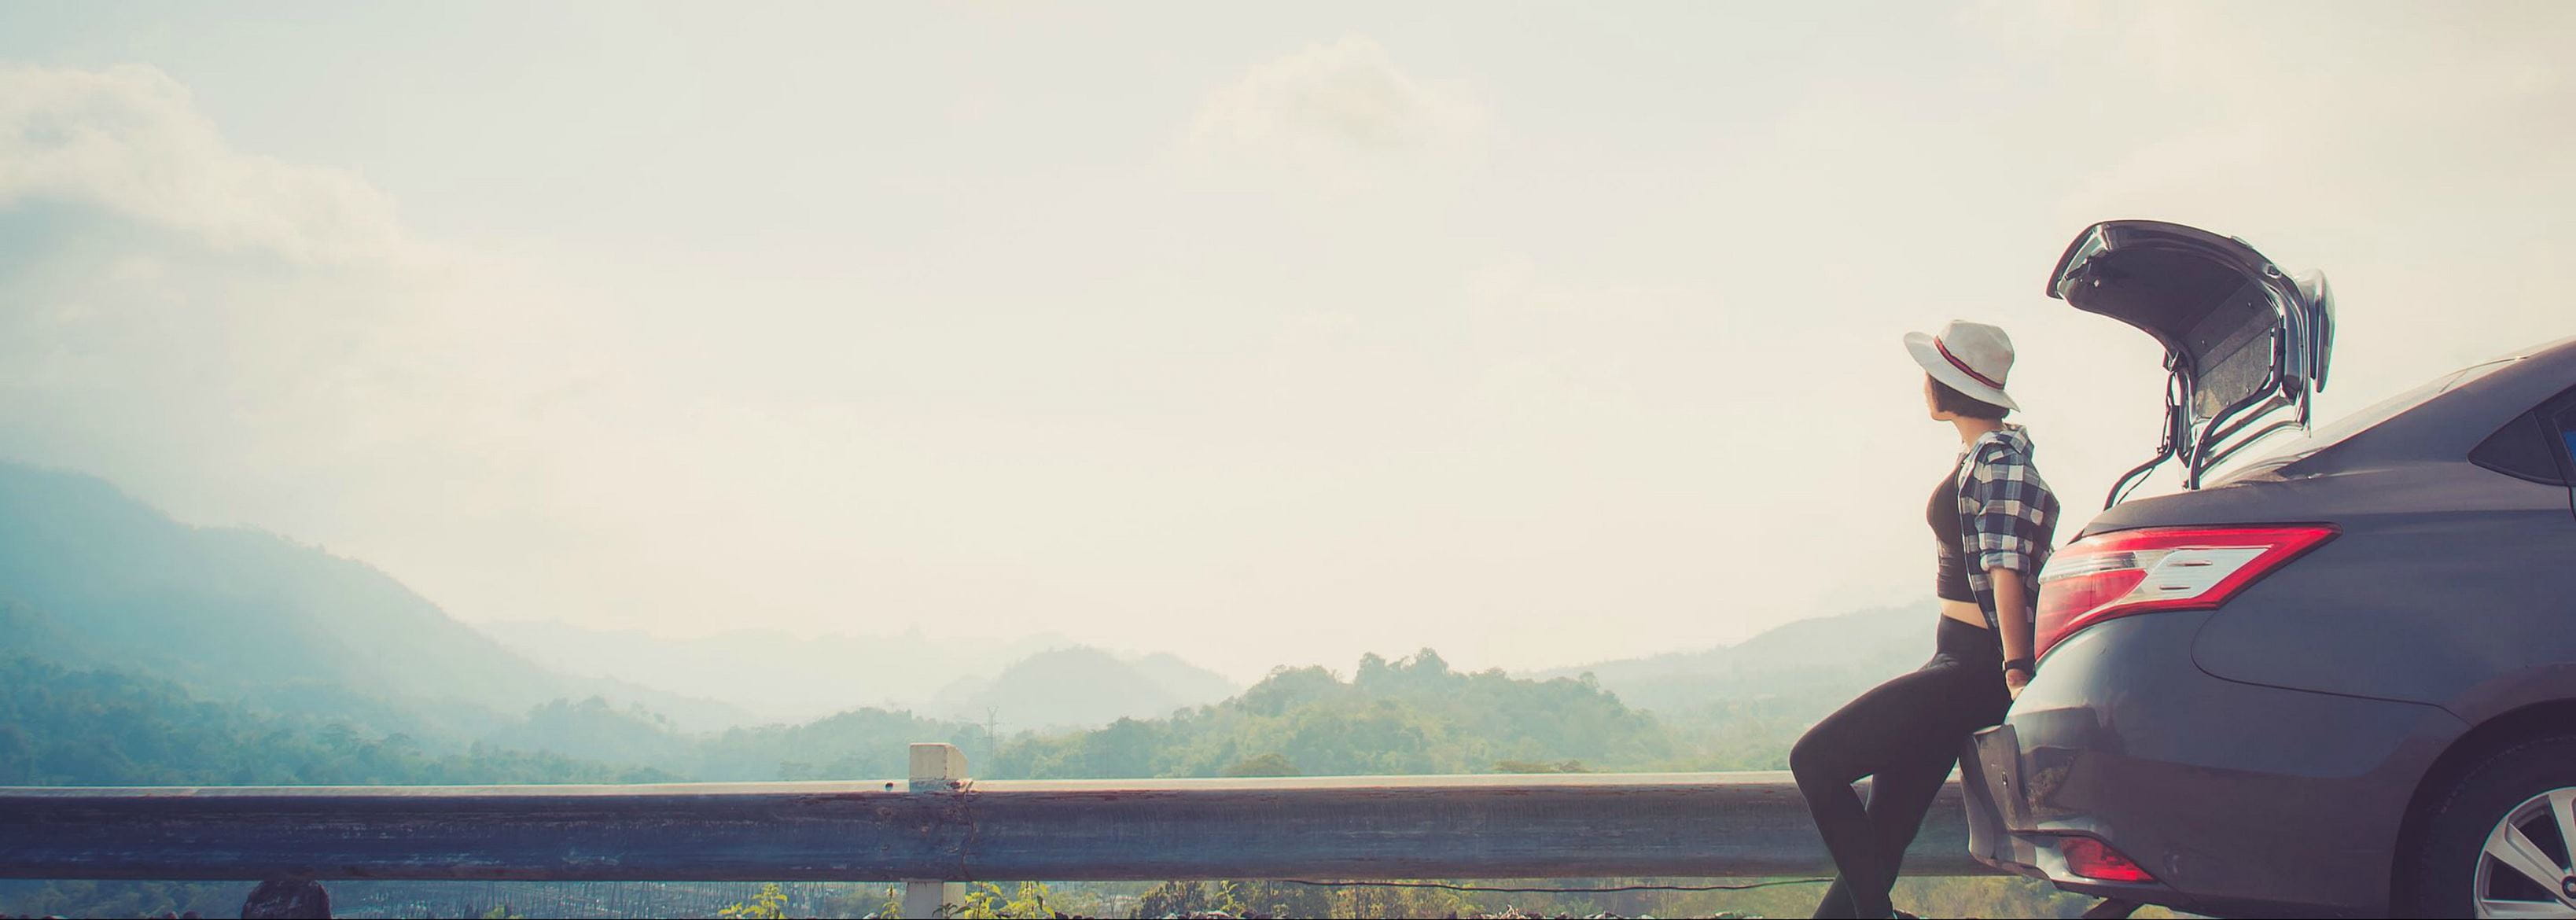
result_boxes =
[2390,737,2576,918]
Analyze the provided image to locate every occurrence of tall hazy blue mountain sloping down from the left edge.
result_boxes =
[0,464,737,729]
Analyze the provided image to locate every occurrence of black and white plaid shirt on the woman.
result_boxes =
[1958,425,2059,629]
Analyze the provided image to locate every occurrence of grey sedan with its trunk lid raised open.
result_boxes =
[1963,222,2576,914]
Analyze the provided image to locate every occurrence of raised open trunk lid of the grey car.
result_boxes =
[2048,222,2334,508]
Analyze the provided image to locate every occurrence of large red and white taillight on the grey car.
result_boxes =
[2033,523,2342,654]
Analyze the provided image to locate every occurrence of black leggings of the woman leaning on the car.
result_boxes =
[1788,616,2012,918]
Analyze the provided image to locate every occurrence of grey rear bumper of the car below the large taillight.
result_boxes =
[1960,613,2467,914]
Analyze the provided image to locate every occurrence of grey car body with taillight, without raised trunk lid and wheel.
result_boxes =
[1963,343,2576,914]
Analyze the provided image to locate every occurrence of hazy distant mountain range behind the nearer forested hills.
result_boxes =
[0,464,1932,737]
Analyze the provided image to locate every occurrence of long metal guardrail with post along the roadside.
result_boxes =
[0,745,1994,914]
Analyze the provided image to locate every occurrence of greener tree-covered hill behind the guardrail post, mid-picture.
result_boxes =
[492,650,1690,781]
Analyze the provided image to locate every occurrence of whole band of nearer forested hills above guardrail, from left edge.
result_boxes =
[0,650,1692,786]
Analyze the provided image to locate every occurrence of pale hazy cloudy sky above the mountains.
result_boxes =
[0,2,2576,680]
